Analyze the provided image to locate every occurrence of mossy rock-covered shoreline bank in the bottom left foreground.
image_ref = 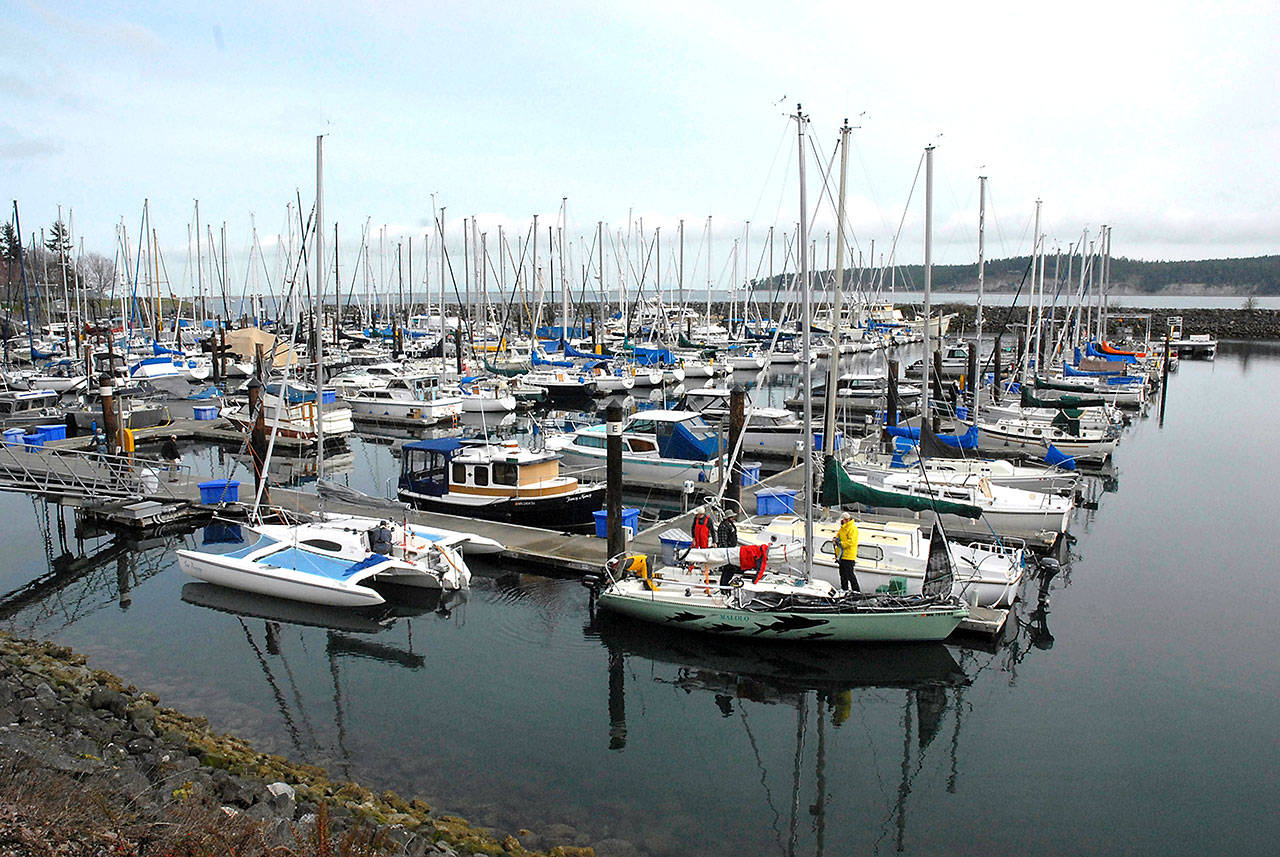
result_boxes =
[0,633,594,857]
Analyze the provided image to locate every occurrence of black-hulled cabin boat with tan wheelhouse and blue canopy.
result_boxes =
[398,437,604,532]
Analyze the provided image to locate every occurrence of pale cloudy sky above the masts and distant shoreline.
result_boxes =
[0,0,1280,295]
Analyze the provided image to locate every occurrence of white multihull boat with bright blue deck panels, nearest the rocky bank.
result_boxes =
[178,515,471,608]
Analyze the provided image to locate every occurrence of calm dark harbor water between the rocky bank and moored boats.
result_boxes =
[0,345,1280,856]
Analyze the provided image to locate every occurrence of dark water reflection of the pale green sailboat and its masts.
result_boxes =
[584,614,977,857]
